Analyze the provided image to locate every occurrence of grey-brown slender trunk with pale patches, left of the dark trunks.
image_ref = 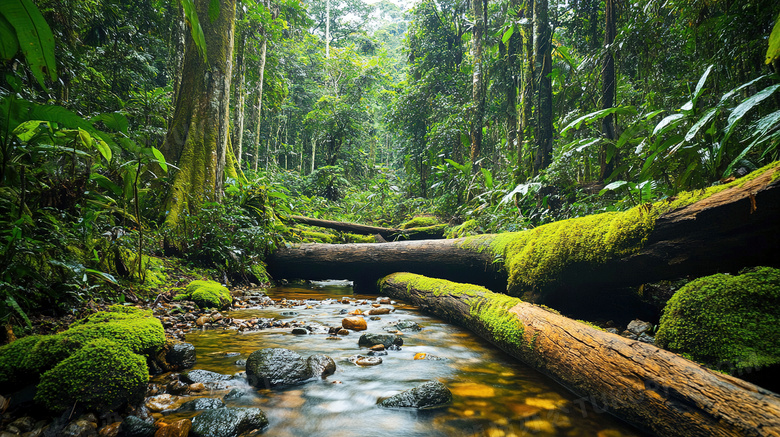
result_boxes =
[471,0,487,172]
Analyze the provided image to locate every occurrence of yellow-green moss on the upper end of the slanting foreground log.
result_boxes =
[379,273,523,344]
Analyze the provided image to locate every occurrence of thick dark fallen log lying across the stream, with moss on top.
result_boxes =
[268,163,780,305]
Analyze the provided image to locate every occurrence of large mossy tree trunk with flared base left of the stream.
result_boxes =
[163,0,236,227]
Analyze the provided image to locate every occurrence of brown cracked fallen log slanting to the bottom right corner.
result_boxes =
[380,273,780,437]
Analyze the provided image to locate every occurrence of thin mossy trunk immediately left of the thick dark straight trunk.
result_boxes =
[516,2,536,182]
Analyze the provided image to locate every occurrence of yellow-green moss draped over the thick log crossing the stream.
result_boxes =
[461,162,780,300]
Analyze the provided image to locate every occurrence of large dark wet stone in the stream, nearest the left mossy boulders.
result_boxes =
[246,348,314,388]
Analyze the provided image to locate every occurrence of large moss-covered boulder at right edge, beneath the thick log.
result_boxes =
[656,267,780,373]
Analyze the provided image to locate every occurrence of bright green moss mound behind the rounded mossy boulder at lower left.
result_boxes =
[24,305,165,373]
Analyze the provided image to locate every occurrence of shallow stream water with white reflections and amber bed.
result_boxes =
[161,283,642,437]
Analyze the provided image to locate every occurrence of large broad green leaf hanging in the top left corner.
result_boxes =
[0,0,57,89]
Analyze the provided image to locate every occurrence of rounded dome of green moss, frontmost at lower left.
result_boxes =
[35,338,149,411]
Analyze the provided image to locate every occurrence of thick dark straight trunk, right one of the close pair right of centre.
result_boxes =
[534,0,552,174]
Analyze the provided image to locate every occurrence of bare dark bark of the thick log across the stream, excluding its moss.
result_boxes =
[268,166,780,296]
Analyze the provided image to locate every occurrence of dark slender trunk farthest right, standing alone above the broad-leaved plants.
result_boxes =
[599,0,617,181]
